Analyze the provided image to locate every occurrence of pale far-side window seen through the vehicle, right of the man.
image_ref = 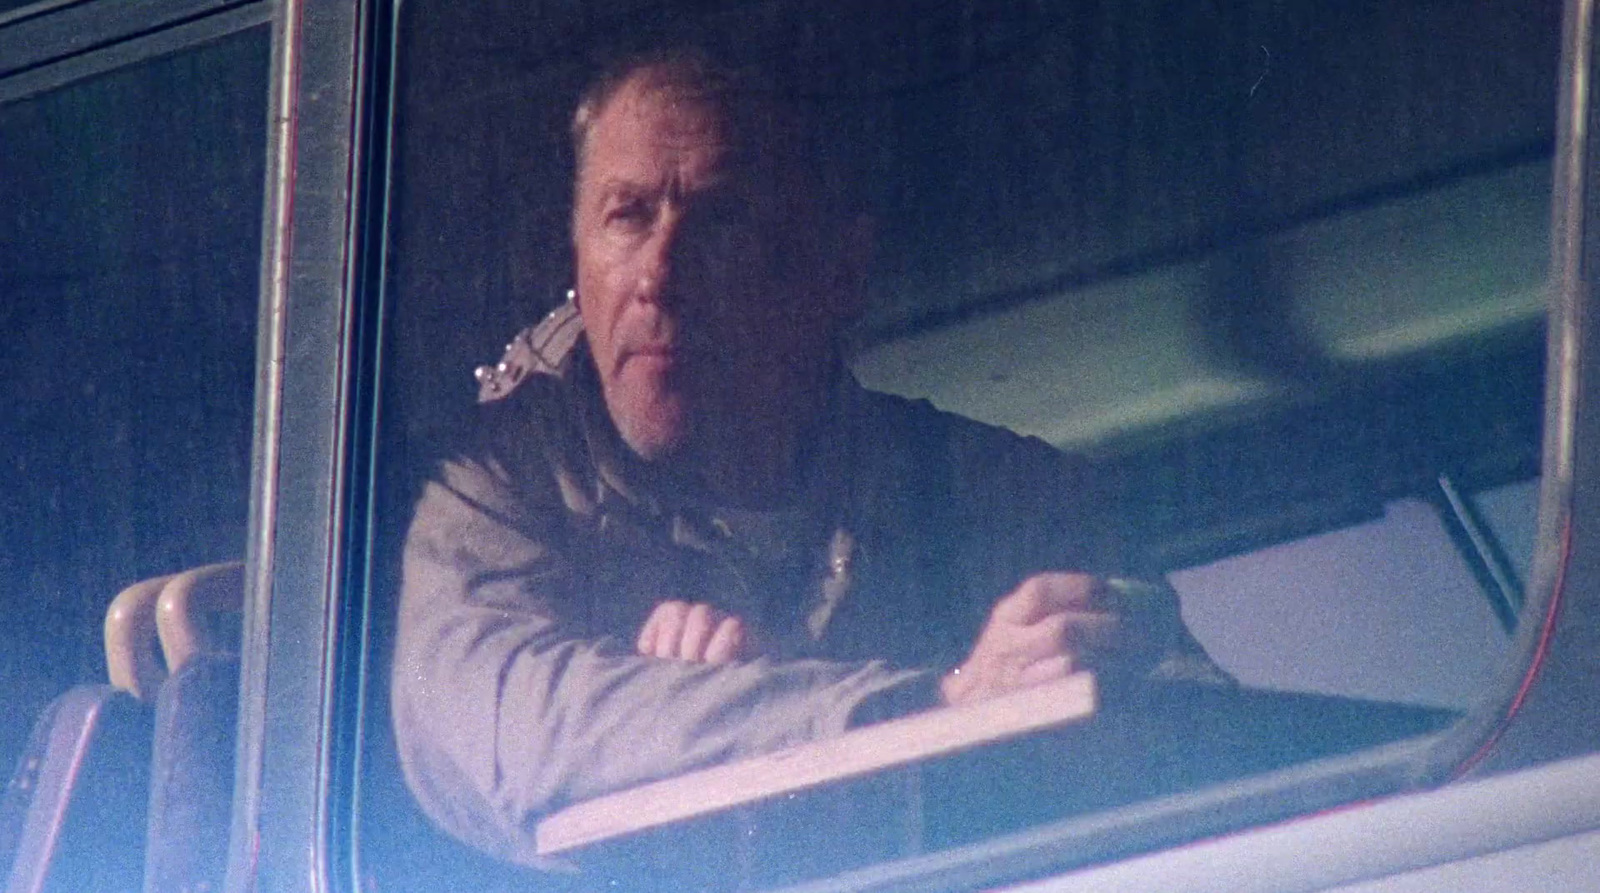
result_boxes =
[1173,483,1538,709]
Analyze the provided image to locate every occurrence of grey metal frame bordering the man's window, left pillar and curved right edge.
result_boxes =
[227,0,1600,891]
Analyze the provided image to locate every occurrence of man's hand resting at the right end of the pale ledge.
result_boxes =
[939,573,1128,704]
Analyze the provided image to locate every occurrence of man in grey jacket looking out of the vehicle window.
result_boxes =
[392,47,1221,863]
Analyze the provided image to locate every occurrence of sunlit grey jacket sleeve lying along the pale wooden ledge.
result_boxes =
[390,459,933,864]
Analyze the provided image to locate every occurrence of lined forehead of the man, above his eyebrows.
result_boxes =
[579,72,730,181]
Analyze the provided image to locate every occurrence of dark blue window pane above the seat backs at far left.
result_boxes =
[0,27,269,784]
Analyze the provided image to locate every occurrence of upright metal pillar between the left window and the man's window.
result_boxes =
[226,0,395,890]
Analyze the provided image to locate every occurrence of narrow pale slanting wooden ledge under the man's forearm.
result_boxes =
[534,672,1096,856]
